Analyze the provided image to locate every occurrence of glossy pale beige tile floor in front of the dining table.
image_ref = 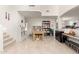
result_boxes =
[3,37,76,54]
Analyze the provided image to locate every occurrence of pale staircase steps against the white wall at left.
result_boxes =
[3,32,15,48]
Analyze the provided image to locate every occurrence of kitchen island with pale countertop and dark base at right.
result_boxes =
[62,33,79,53]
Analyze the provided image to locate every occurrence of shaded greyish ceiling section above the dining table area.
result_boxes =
[19,11,57,19]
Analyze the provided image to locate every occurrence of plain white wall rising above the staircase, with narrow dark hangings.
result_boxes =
[0,6,23,41]
